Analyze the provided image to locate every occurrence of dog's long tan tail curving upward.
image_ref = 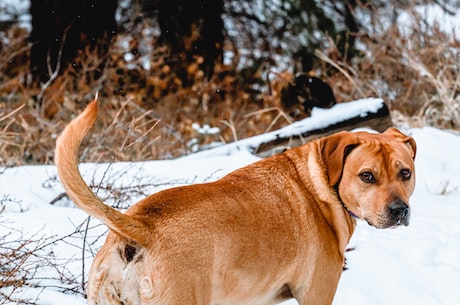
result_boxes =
[54,101,147,245]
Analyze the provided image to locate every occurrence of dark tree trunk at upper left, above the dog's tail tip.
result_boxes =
[30,0,118,82]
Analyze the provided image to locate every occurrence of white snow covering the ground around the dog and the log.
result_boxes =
[0,99,460,305]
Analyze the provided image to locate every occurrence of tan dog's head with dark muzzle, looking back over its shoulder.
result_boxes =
[321,128,416,228]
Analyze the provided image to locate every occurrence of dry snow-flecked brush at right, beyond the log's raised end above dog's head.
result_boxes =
[344,6,460,130]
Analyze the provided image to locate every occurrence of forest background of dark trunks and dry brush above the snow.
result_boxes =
[0,0,460,167]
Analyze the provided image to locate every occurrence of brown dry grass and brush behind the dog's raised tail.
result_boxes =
[0,34,292,166]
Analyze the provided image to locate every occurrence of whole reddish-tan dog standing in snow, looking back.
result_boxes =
[55,102,416,305]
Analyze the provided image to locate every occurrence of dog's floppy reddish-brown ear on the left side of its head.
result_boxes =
[319,131,360,187]
